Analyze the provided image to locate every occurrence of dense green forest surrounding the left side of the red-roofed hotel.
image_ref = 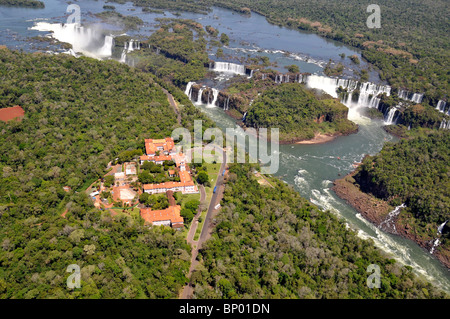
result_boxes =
[0,49,215,298]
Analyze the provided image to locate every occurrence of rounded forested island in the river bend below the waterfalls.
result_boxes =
[245,83,357,142]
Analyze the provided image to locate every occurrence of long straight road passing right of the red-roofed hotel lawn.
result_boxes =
[180,148,227,299]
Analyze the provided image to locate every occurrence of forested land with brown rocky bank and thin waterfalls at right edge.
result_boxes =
[333,131,450,268]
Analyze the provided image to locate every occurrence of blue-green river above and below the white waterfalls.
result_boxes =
[0,0,450,292]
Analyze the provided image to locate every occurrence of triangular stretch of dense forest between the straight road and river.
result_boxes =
[192,164,444,299]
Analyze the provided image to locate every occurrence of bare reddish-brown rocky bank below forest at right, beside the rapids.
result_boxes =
[332,170,450,268]
